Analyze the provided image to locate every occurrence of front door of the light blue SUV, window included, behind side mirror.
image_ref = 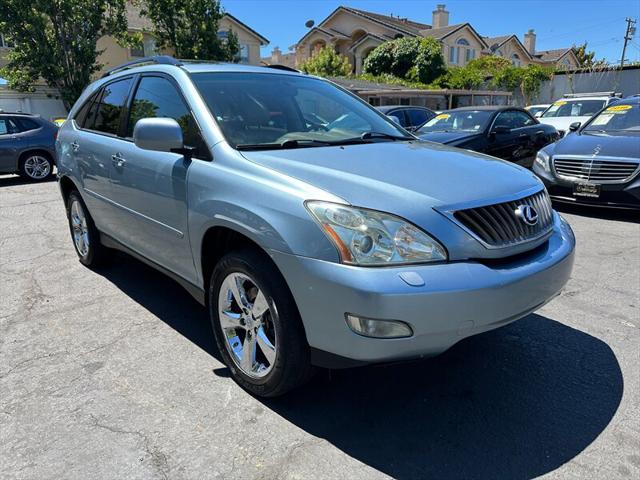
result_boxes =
[109,73,208,279]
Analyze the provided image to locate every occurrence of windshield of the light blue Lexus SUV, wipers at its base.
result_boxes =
[192,72,414,150]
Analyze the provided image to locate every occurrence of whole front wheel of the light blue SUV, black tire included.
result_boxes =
[209,250,313,397]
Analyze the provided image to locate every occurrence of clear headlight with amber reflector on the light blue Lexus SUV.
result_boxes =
[306,201,447,266]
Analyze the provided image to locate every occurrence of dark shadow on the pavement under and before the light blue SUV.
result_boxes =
[103,254,623,479]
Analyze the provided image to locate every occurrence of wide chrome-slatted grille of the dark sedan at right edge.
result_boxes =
[553,158,640,183]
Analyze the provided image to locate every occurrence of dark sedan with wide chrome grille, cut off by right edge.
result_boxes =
[533,97,640,209]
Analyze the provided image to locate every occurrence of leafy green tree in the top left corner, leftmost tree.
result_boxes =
[0,0,131,108]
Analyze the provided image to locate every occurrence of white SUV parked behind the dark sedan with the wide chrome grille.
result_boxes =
[538,92,620,136]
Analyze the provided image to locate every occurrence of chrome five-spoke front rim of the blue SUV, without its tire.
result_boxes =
[218,273,278,378]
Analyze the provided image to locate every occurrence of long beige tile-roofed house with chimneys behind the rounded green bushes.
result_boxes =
[278,5,578,74]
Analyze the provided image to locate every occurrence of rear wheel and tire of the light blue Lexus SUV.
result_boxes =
[67,191,107,268]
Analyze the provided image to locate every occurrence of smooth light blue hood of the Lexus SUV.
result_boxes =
[241,141,540,213]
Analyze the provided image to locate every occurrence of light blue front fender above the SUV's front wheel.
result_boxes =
[187,147,339,279]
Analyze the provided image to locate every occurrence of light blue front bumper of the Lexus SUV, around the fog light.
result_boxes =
[271,214,575,367]
